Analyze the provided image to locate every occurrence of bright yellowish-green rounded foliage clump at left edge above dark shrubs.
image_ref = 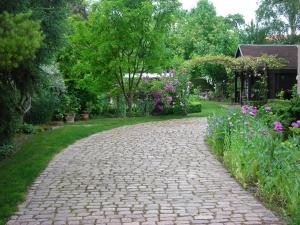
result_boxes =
[0,12,42,70]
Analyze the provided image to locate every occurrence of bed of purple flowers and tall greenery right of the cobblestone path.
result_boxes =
[207,106,300,224]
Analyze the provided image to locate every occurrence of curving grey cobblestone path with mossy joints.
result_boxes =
[7,119,282,225]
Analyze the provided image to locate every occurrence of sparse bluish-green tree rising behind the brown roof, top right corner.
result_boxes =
[256,0,300,43]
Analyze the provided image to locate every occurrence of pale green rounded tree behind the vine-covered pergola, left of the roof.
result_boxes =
[173,0,238,59]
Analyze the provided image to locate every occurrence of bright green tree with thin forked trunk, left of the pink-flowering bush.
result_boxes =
[65,0,178,114]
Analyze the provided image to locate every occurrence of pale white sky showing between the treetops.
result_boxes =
[179,0,257,22]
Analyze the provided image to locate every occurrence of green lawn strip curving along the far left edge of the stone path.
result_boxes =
[0,101,224,225]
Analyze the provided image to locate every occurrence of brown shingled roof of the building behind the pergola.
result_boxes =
[235,44,298,70]
